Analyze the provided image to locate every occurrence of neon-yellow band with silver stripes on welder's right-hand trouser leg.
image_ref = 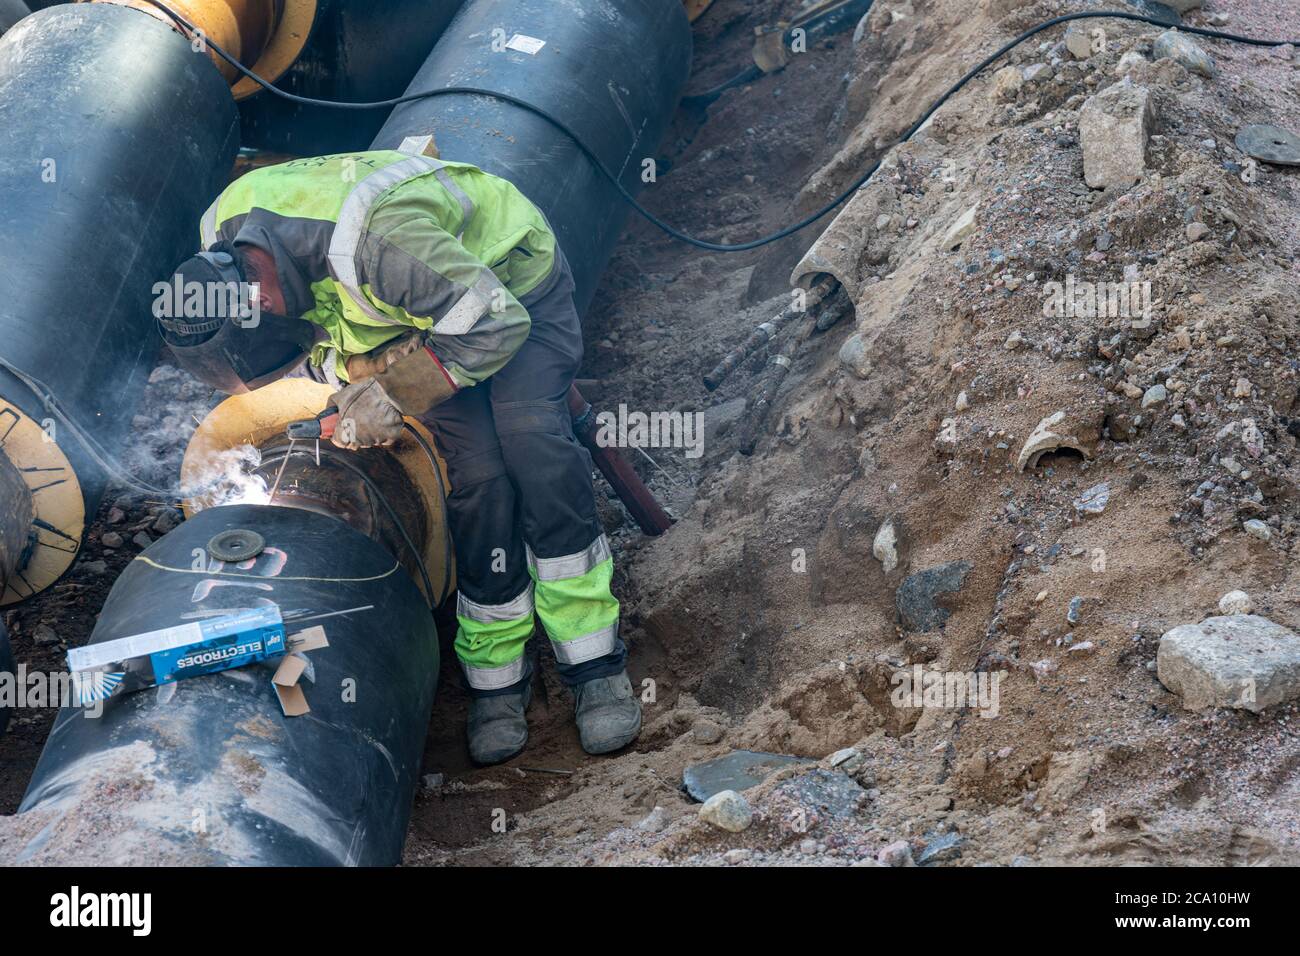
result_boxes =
[528,535,619,665]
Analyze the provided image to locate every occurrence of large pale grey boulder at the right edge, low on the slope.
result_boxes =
[1156,614,1300,713]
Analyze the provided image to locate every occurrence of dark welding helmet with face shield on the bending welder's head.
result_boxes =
[153,242,316,395]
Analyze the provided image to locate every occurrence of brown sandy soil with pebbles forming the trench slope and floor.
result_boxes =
[0,0,1300,865]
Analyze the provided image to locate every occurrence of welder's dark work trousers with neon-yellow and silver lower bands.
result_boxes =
[421,254,627,695]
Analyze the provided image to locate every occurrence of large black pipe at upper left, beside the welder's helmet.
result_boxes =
[0,4,238,515]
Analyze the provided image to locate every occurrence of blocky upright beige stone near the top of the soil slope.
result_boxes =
[1079,81,1154,189]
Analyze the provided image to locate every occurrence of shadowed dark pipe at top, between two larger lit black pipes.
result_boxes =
[239,0,464,156]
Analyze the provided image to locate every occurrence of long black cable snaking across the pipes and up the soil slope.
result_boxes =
[146,0,1300,252]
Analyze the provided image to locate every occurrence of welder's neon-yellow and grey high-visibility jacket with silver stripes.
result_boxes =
[200,150,556,388]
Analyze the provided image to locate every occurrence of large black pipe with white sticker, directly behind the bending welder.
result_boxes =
[373,0,690,312]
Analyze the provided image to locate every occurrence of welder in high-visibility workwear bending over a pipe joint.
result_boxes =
[155,151,641,763]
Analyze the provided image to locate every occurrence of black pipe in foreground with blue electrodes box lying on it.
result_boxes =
[4,505,438,866]
